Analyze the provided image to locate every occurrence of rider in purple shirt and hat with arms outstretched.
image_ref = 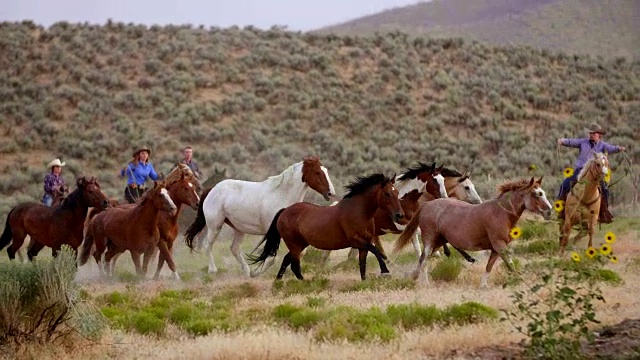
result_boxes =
[558,123,625,224]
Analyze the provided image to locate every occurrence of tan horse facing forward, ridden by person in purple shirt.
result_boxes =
[560,153,609,255]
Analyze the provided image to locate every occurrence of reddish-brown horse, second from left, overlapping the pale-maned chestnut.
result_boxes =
[80,182,177,276]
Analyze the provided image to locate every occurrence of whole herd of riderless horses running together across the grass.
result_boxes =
[0,157,564,285]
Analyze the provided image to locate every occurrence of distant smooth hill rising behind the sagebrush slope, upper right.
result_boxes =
[319,0,640,59]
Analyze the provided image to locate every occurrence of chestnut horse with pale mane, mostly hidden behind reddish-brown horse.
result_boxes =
[86,167,200,280]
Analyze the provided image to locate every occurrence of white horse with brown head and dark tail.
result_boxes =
[185,157,335,276]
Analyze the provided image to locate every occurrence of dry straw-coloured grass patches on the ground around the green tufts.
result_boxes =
[1,222,640,359]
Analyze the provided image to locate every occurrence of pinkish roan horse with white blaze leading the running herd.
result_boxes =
[395,178,553,287]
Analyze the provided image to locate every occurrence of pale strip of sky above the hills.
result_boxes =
[0,0,424,31]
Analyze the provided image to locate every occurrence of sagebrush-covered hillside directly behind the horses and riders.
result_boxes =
[0,22,640,218]
